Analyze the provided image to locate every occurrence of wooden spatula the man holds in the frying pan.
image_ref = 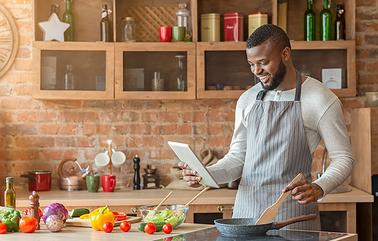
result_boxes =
[256,173,303,224]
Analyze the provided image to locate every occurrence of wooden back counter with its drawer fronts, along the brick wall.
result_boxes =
[16,188,374,233]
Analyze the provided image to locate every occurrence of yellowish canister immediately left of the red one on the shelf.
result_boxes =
[201,13,220,42]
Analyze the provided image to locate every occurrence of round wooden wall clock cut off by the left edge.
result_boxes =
[0,4,19,77]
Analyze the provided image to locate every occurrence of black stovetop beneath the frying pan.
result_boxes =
[156,227,347,241]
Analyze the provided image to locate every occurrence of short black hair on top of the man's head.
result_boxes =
[247,24,291,50]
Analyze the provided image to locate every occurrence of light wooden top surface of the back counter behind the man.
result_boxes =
[16,185,374,208]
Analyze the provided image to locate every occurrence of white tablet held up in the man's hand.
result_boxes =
[168,141,219,188]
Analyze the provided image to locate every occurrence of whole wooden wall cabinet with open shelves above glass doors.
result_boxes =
[33,0,356,99]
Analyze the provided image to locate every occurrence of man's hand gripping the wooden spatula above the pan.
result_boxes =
[282,179,324,204]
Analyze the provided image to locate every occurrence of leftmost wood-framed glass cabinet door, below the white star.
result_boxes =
[33,42,114,99]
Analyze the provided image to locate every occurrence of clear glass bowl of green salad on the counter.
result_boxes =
[139,205,189,228]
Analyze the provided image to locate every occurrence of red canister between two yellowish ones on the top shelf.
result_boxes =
[223,12,244,41]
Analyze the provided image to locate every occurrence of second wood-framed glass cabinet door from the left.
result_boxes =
[115,43,195,99]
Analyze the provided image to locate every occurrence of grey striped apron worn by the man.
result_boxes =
[233,73,320,230]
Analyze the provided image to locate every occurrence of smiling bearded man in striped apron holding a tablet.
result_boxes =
[181,24,353,229]
